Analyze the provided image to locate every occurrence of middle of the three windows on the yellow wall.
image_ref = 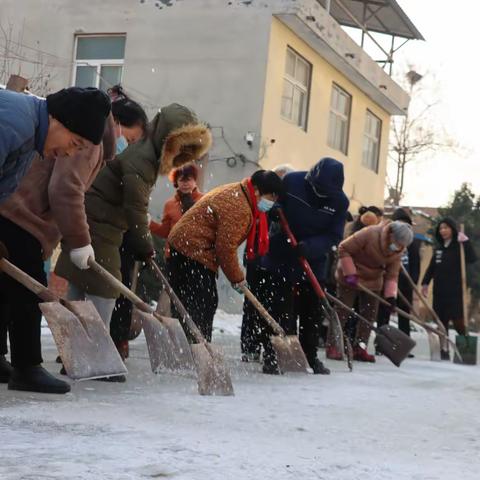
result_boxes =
[328,84,352,155]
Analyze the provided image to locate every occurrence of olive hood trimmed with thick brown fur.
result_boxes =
[149,103,212,175]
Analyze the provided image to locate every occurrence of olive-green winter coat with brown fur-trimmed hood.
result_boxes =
[55,104,211,298]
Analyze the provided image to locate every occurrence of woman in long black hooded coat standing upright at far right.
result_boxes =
[422,217,477,360]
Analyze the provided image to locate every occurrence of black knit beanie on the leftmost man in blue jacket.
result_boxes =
[47,87,111,145]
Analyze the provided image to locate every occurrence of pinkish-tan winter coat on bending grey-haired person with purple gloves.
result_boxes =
[336,222,404,298]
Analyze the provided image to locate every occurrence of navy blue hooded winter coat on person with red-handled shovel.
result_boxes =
[261,158,349,282]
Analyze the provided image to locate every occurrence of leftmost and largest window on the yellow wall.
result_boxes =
[281,48,312,130]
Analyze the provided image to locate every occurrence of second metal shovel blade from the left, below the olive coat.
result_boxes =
[132,308,195,373]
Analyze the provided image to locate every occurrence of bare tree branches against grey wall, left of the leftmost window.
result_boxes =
[0,19,57,96]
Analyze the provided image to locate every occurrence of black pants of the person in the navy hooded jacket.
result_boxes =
[259,271,323,365]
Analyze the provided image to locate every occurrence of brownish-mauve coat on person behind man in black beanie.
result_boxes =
[0,116,115,259]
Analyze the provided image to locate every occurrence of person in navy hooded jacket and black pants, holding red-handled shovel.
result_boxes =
[260,158,349,374]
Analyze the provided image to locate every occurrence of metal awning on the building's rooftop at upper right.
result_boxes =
[317,0,425,40]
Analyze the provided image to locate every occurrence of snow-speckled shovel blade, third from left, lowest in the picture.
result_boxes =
[191,343,234,396]
